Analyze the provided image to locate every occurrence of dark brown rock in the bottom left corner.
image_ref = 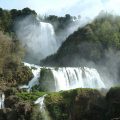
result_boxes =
[0,102,32,120]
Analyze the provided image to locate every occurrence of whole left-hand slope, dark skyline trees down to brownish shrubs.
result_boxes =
[0,8,37,85]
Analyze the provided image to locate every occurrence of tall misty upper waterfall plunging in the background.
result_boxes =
[16,17,59,64]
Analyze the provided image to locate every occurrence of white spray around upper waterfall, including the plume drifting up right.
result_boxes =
[15,16,92,64]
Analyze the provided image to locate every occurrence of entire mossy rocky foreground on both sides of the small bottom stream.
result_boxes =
[0,87,120,120]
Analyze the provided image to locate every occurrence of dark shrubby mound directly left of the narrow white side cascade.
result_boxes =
[0,64,33,87]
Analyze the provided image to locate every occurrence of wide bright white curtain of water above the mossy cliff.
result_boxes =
[51,67,105,91]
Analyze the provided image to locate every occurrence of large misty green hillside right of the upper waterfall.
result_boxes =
[41,13,120,66]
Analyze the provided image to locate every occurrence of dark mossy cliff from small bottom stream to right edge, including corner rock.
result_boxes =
[45,87,120,120]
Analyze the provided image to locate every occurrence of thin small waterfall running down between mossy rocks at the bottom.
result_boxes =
[34,94,51,120]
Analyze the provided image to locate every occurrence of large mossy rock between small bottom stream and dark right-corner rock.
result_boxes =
[45,89,105,120]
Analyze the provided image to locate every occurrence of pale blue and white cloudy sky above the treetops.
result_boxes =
[0,0,120,17]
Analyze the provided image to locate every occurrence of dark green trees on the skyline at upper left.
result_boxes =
[0,8,37,34]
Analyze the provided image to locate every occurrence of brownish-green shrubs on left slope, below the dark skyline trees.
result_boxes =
[0,31,32,85]
